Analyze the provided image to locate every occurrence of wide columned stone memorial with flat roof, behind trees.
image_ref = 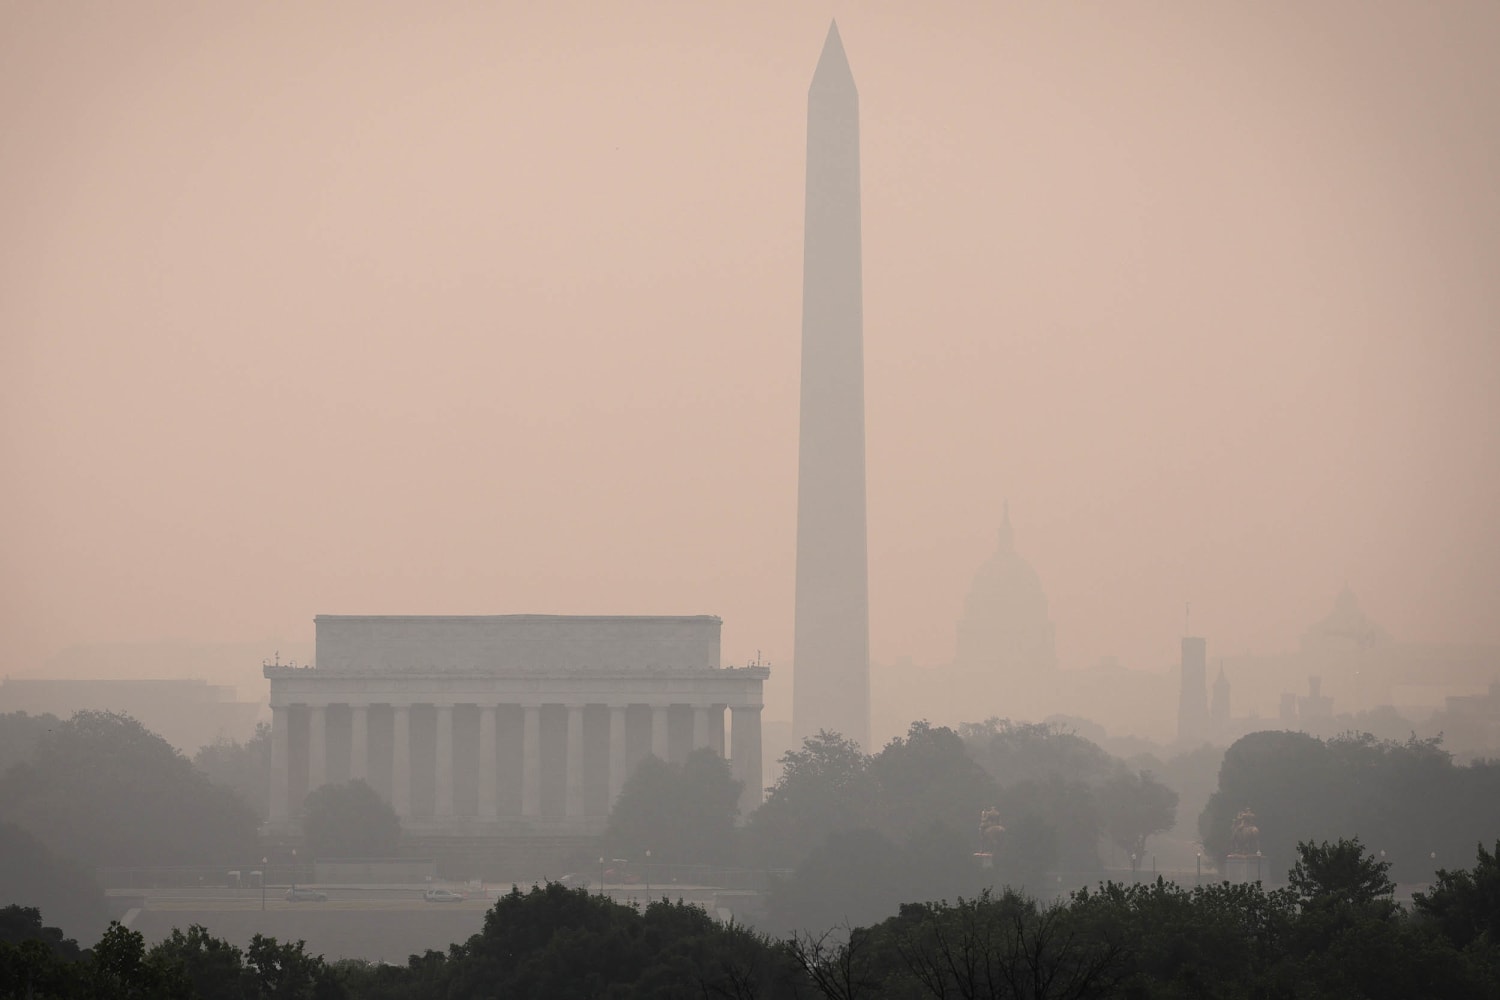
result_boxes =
[266,615,770,837]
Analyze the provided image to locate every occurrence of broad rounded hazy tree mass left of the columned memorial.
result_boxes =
[0,712,257,865]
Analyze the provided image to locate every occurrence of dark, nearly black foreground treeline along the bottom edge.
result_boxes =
[0,840,1500,1000]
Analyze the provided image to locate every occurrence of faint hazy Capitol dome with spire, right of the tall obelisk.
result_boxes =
[954,504,1058,678]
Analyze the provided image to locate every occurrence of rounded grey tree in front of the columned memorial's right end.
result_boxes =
[605,748,740,865]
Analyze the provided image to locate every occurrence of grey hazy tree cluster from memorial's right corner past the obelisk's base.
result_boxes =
[603,720,1178,931]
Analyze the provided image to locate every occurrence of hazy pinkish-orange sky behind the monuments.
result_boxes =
[0,0,1500,718]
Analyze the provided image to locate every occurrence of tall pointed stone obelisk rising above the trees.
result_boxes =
[792,24,870,750]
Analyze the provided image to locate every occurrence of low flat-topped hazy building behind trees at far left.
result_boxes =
[0,678,264,756]
